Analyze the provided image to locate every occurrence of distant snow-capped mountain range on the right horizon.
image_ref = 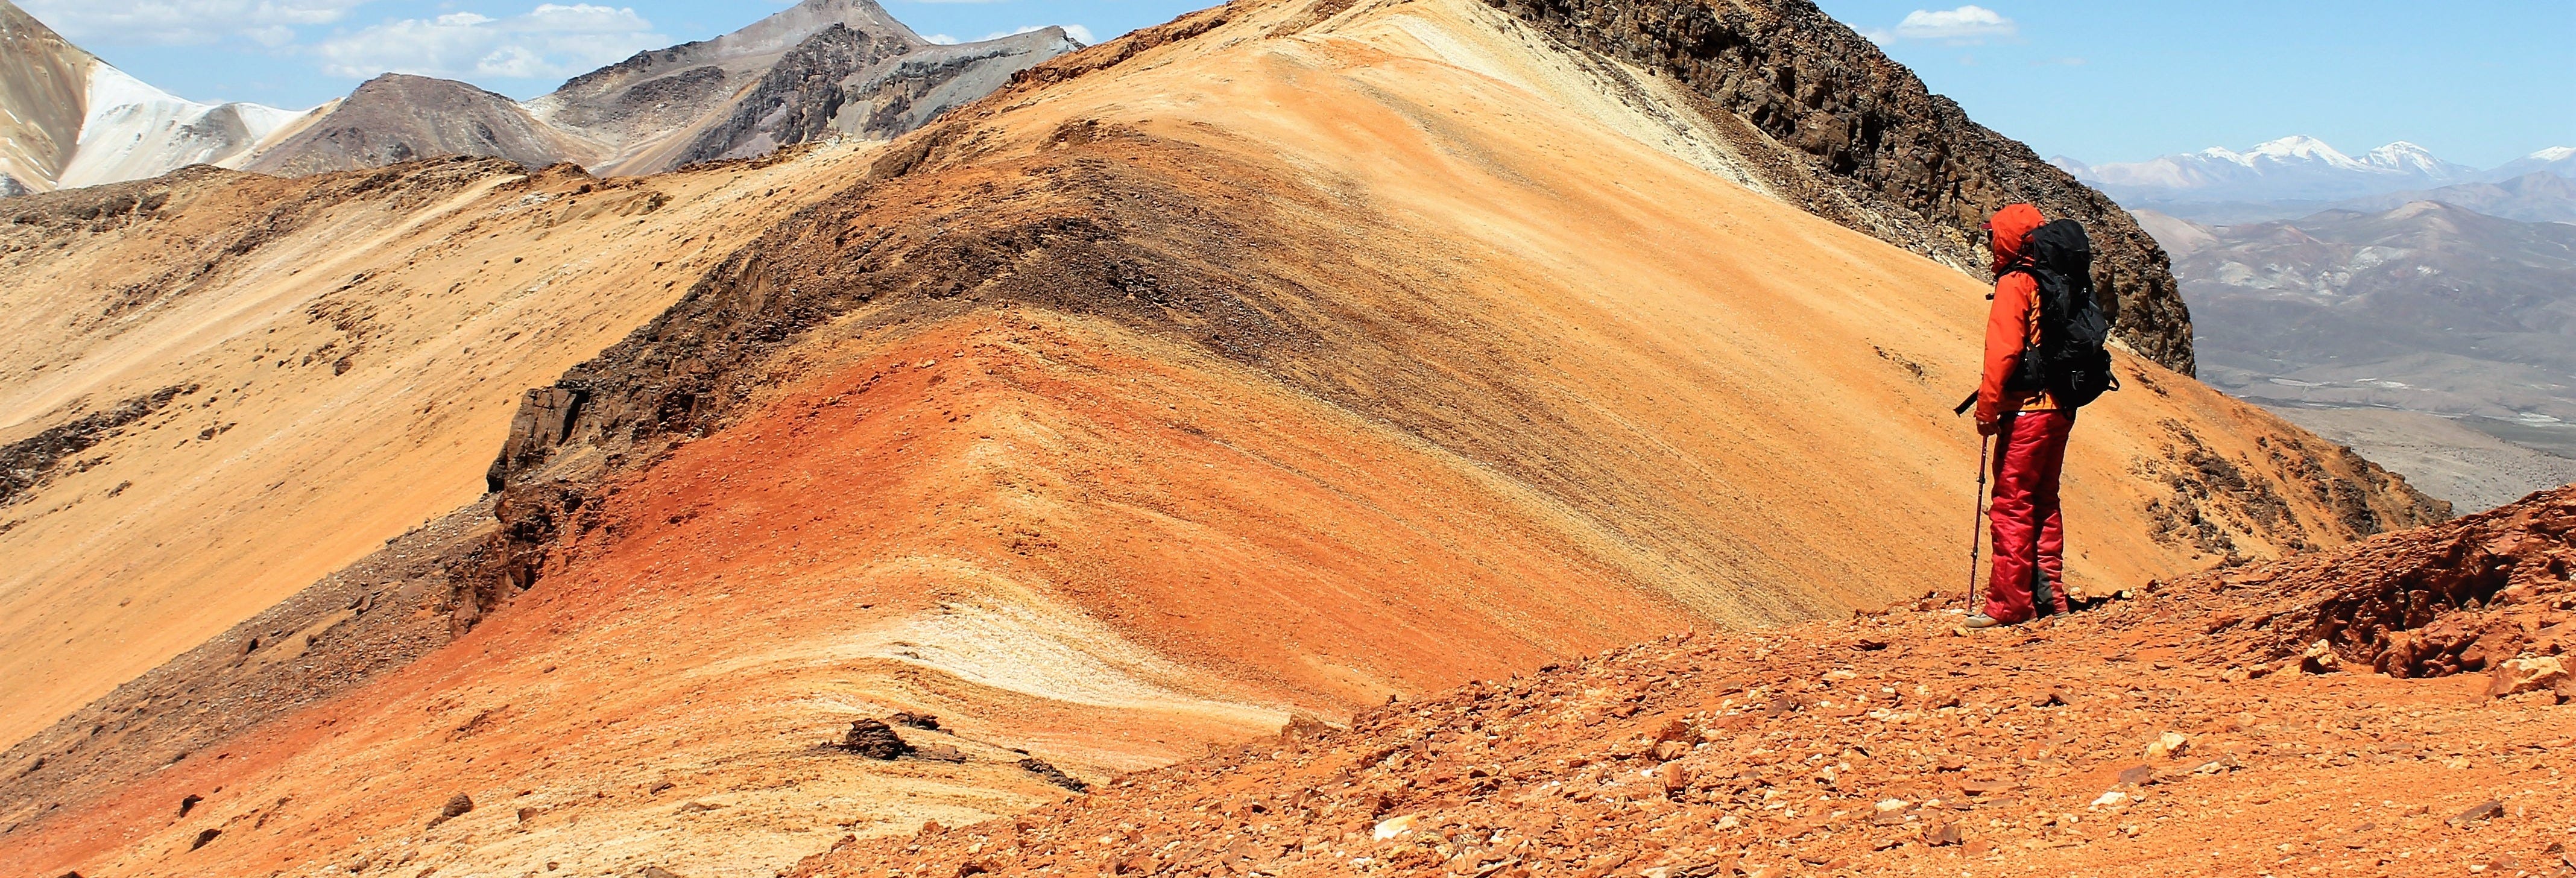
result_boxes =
[2051,136,2576,224]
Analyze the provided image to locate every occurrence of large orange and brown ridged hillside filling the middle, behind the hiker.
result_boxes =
[0,0,2440,876]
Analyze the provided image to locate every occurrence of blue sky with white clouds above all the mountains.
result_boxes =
[18,0,2576,168]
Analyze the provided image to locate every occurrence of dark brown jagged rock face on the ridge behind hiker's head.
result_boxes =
[1486,0,2195,373]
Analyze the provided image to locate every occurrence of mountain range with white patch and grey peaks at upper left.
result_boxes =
[0,0,1079,196]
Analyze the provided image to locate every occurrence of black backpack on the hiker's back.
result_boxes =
[2004,219,2120,407]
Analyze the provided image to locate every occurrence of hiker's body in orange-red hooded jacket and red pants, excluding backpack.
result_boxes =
[1968,203,2076,628]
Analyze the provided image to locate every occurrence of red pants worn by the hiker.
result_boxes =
[1986,412,2076,623]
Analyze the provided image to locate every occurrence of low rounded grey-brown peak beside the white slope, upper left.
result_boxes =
[247,72,593,178]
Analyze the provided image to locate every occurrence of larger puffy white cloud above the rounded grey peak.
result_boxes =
[314,2,670,80]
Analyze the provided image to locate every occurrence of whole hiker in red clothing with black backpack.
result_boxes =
[1968,203,2118,628]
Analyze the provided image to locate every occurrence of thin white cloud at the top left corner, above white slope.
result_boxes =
[18,0,368,46]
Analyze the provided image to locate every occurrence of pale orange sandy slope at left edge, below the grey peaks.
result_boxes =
[0,147,863,742]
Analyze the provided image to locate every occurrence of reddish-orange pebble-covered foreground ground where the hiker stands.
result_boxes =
[796,487,2576,878]
